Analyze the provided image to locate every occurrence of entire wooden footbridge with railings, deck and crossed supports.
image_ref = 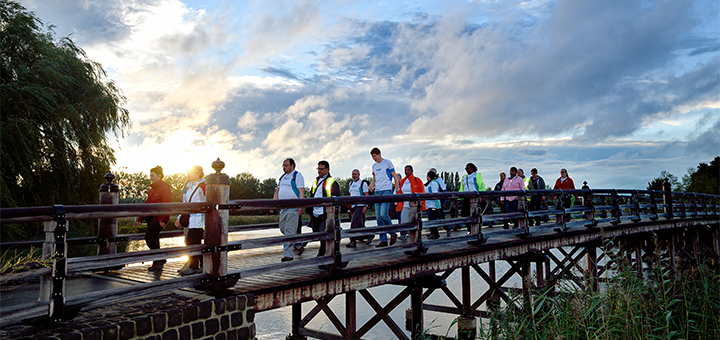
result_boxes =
[0,161,720,339]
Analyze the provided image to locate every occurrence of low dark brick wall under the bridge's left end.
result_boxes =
[0,292,255,340]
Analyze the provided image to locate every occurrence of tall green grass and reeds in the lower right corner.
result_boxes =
[478,258,720,340]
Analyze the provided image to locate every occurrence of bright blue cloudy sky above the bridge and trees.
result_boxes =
[20,0,720,189]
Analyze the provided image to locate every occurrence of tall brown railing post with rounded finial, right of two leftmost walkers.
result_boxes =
[203,158,229,291]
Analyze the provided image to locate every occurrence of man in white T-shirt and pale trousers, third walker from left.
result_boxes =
[273,158,305,262]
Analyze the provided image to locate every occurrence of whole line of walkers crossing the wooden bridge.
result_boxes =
[137,148,575,275]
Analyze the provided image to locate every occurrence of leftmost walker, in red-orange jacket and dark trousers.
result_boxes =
[137,165,172,272]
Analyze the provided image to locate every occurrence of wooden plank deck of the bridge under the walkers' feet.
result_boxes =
[101,219,717,311]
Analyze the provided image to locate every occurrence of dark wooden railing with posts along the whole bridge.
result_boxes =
[0,160,720,325]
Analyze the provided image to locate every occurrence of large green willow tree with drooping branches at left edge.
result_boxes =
[0,0,130,212]
